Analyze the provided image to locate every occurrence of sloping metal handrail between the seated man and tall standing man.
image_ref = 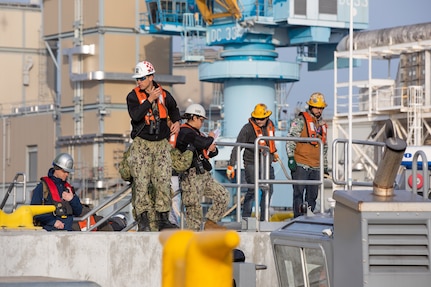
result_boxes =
[73,183,132,231]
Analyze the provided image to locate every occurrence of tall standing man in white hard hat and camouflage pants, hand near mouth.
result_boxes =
[127,61,181,231]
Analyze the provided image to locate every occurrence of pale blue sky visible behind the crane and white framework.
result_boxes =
[279,0,431,116]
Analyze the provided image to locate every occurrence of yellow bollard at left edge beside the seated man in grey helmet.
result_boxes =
[0,205,55,229]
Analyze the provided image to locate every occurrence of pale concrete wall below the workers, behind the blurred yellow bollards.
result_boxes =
[0,230,278,287]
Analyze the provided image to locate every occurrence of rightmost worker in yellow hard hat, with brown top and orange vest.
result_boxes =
[286,93,328,217]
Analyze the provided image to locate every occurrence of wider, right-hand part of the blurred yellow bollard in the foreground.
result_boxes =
[185,230,239,287]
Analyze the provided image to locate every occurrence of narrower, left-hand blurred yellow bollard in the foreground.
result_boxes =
[159,230,194,287]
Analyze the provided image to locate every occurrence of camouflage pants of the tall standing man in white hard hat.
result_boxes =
[128,137,172,215]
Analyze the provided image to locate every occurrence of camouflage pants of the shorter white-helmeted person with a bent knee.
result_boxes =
[181,168,229,231]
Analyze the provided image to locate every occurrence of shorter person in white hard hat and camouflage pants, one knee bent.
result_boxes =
[176,104,229,231]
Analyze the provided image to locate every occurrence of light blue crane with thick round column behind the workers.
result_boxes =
[141,0,368,137]
